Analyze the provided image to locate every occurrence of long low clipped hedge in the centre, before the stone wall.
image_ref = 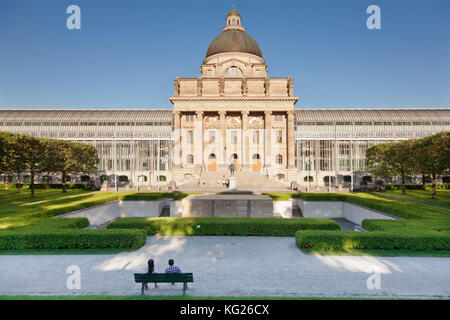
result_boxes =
[108,218,339,237]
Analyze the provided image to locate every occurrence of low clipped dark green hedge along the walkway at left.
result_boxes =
[0,229,146,250]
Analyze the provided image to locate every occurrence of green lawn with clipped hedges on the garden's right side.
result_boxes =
[284,190,450,256]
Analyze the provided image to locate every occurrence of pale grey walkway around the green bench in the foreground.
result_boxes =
[0,237,450,298]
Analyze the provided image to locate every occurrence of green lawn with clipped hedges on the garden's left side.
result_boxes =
[0,189,186,254]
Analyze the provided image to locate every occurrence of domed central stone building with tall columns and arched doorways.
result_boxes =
[169,11,299,179]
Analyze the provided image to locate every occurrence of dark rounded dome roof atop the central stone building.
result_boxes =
[206,29,262,58]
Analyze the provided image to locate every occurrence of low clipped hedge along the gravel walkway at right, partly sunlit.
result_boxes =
[295,230,450,251]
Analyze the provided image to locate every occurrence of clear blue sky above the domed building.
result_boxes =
[0,0,450,108]
